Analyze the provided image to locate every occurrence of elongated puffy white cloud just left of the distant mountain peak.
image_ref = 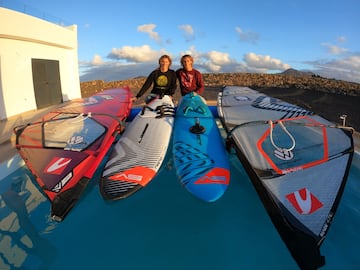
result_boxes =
[244,53,290,70]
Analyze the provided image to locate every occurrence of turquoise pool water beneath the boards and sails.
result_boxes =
[0,149,360,270]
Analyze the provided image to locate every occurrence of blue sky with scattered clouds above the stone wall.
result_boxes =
[5,0,360,83]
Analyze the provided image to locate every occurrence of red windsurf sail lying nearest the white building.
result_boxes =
[14,88,131,221]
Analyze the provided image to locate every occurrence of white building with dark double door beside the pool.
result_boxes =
[0,7,81,120]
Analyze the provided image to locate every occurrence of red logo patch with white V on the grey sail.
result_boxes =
[286,188,323,215]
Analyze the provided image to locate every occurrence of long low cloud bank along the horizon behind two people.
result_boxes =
[79,45,360,83]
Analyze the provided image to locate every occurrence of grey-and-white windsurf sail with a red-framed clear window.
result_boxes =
[218,87,354,269]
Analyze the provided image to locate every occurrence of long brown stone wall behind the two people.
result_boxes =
[80,73,360,97]
